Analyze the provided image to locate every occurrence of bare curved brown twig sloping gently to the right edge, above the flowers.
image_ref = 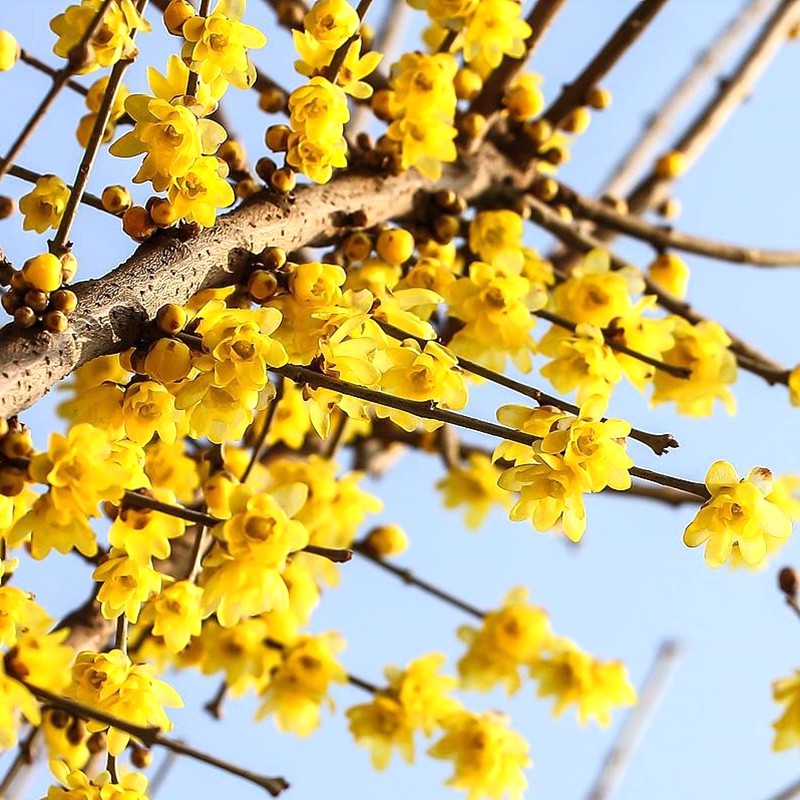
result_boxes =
[559,183,800,267]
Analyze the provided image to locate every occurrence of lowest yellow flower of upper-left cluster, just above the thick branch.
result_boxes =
[167,156,236,228]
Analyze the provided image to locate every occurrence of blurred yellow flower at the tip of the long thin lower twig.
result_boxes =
[458,587,552,694]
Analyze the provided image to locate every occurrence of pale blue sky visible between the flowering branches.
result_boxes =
[0,0,800,800]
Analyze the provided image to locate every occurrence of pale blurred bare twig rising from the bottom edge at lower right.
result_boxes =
[587,641,681,800]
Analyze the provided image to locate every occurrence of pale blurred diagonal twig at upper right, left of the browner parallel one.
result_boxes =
[599,0,775,195]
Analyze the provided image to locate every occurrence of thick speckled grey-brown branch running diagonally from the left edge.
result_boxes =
[0,144,523,417]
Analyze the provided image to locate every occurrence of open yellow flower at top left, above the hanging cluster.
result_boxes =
[181,0,267,89]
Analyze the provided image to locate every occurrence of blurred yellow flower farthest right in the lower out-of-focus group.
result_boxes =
[530,639,636,727]
